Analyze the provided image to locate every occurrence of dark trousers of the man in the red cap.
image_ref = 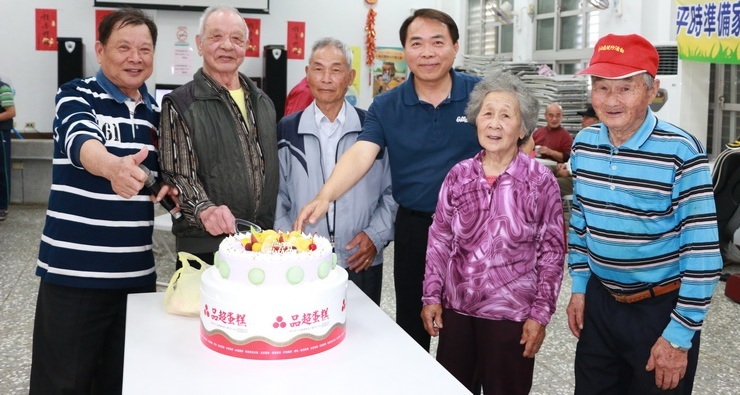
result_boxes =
[575,276,701,395]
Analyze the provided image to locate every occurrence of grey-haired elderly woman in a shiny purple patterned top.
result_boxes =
[421,73,565,395]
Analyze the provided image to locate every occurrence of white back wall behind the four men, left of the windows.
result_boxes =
[0,0,464,132]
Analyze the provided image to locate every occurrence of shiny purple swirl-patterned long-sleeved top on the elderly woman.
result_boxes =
[422,151,565,325]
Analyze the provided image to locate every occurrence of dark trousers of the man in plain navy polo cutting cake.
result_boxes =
[393,207,432,351]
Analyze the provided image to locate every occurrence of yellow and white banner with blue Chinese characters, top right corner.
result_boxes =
[676,0,740,64]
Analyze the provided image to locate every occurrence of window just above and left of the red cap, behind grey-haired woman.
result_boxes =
[533,0,599,74]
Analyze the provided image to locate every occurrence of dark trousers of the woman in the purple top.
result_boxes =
[437,309,534,395]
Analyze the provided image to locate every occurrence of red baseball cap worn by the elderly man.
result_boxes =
[578,34,658,80]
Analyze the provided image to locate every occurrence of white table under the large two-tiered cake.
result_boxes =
[123,282,470,395]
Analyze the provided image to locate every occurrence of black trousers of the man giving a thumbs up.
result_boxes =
[29,281,155,395]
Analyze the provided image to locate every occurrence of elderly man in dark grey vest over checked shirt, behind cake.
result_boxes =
[160,6,279,267]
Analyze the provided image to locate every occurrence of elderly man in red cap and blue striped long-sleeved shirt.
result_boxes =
[567,34,722,394]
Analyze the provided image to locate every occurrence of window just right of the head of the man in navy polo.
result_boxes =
[466,0,514,58]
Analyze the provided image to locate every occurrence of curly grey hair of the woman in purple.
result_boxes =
[465,72,540,145]
